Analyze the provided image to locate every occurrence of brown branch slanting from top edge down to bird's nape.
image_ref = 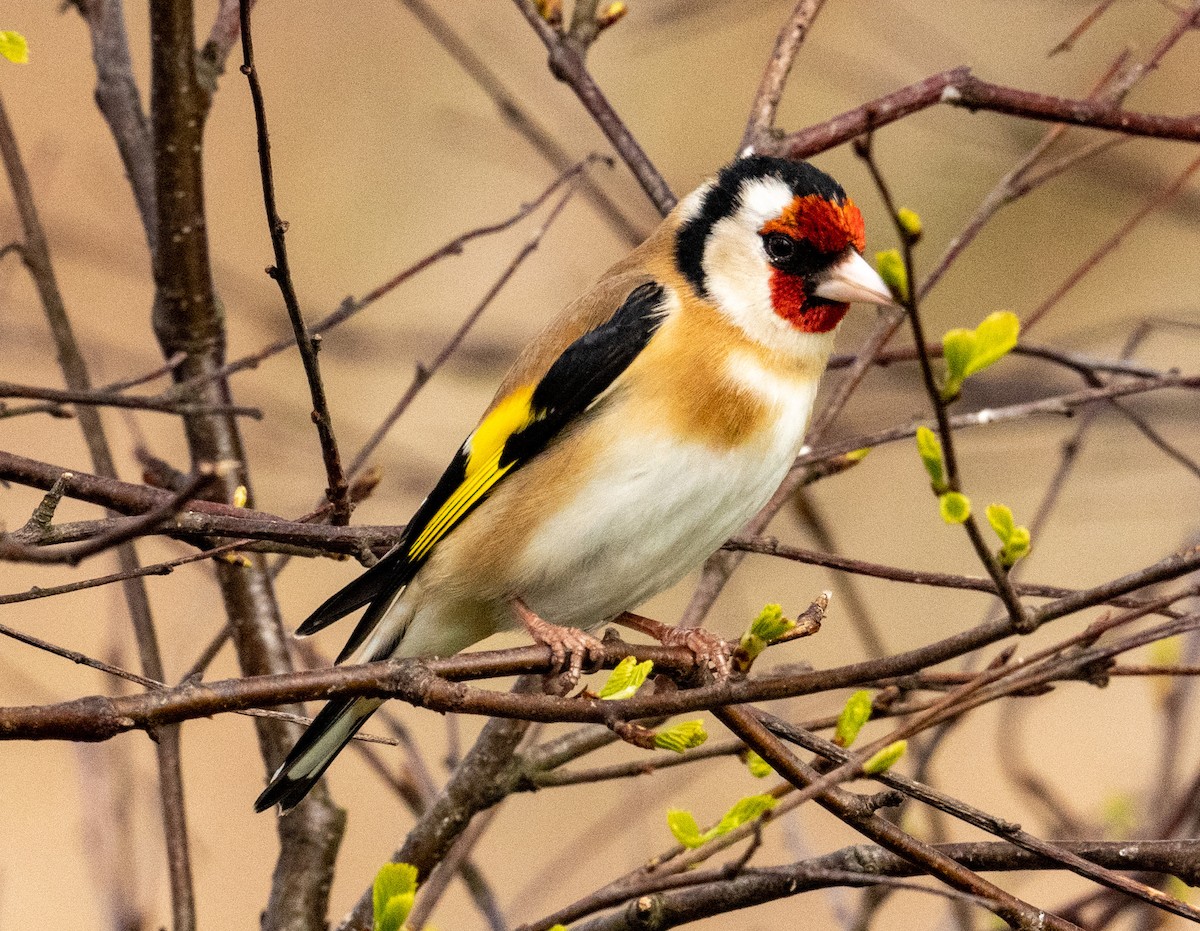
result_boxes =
[514,0,676,215]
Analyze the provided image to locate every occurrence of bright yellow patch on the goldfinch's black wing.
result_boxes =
[408,385,538,559]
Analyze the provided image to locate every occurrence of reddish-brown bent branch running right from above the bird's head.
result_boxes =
[762,67,1200,158]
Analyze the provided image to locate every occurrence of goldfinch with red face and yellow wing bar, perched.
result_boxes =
[254,154,894,811]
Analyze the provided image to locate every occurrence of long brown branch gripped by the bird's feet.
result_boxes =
[9,580,1200,740]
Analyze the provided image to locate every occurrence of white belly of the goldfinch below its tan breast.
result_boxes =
[516,367,816,627]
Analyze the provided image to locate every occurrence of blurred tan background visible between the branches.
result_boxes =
[0,0,1200,931]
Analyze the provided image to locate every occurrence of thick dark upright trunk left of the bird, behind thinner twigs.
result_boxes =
[150,0,346,931]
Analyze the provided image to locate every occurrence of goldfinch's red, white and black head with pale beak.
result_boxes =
[676,156,893,348]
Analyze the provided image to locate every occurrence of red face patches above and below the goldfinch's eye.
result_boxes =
[760,194,866,334]
